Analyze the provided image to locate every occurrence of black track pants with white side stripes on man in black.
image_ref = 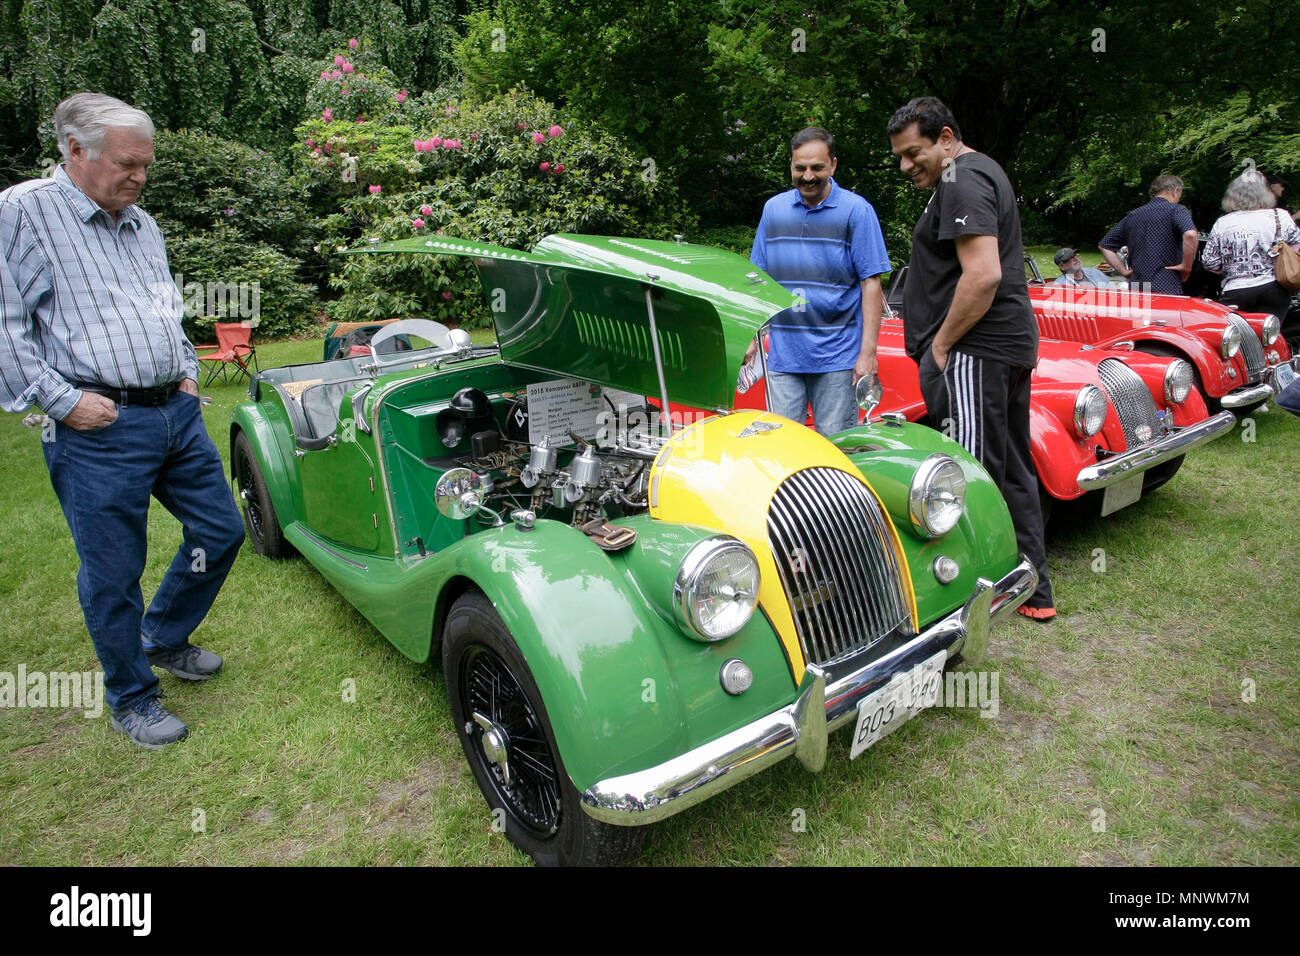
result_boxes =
[919,349,1053,607]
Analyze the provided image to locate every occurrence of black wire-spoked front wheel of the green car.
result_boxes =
[442,591,645,866]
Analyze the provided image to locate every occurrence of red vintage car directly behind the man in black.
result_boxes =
[736,315,1236,516]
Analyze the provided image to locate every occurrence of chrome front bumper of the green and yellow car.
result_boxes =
[582,559,1039,826]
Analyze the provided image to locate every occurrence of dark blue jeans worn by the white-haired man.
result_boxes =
[43,392,243,713]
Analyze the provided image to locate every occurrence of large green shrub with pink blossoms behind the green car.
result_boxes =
[315,90,692,325]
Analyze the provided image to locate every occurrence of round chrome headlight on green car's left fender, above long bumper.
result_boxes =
[672,535,758,641]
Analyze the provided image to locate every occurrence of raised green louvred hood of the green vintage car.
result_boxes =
[351,235,798,408]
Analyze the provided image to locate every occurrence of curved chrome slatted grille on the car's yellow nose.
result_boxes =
[767,468,910,663]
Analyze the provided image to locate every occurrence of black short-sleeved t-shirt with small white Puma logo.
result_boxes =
[902,152,1039,367]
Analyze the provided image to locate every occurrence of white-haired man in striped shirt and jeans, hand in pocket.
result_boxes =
[0,92,243,749]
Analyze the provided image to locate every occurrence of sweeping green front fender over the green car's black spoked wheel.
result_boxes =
[295,515,796,791]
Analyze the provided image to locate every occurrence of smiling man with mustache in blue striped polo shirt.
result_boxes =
[749,126,889,434]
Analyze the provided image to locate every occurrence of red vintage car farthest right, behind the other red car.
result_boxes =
[1019,256,1300,412]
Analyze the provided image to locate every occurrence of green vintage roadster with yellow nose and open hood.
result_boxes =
[230,235,1036,864]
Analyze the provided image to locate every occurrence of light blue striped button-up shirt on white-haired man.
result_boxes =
[0,166,199,420]
